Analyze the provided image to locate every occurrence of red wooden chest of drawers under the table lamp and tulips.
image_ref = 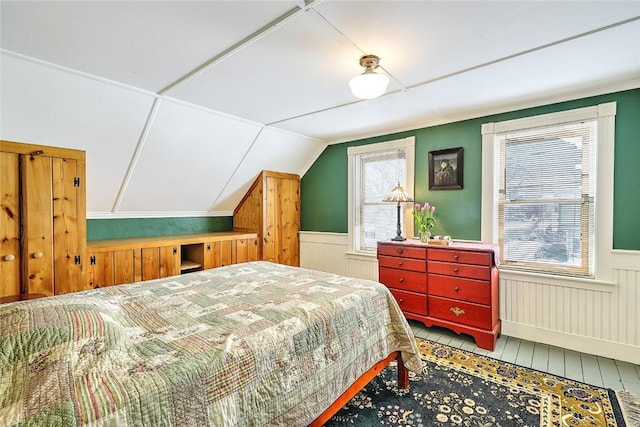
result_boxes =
[378,240,500,350]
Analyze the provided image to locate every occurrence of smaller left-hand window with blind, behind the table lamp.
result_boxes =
[347,137,414,253]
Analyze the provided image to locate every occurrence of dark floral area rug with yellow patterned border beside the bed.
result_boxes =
[326,339,640,427]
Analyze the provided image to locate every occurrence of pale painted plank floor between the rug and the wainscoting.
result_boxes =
[409,320,640,396]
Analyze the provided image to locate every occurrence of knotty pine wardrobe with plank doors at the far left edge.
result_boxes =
[0,141,86,299]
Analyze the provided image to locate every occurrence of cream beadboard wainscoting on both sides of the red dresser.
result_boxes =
[300,232,640,364]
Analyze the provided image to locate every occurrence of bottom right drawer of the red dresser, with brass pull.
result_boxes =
[429,296,493,330]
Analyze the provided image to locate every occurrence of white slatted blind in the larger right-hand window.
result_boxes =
[496,120,596,277]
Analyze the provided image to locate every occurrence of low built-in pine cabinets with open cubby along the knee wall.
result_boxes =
[87,232,258,288]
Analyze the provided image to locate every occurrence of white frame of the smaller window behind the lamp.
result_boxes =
[347,136,415,256]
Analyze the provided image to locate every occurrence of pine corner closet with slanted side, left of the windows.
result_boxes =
[233,171,300,266]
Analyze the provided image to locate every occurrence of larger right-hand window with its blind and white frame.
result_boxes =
[483,104,615,278]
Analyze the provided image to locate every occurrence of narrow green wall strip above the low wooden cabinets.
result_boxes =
[87,216,233,240]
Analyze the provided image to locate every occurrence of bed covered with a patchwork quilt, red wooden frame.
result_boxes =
[0,261,420,426]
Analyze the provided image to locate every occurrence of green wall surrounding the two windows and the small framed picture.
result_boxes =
[301,89,640,250]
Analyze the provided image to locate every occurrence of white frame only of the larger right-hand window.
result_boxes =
[481,102,616,288]
